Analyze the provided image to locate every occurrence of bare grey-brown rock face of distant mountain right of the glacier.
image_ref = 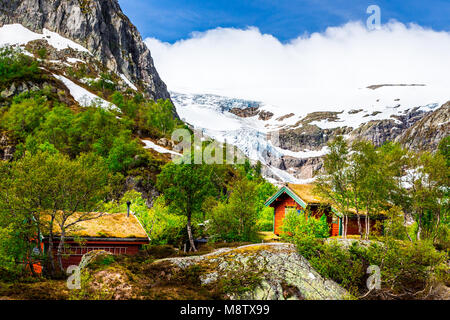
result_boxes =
[265,102,444,179]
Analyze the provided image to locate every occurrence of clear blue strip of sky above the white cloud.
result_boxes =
[119,0,450,43]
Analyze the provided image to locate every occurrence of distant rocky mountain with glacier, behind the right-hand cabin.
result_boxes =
[172,90,450,183]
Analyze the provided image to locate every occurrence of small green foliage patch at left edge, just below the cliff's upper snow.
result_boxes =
[0,47,40,87]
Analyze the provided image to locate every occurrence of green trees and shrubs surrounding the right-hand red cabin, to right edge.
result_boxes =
[283,137,450,299]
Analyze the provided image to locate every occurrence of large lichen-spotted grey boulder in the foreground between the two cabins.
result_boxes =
[156,243,349,300]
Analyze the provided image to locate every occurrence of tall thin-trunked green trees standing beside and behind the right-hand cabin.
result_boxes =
[316,137,450,247]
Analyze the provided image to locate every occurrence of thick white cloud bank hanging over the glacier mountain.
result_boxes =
[146,22,450,113]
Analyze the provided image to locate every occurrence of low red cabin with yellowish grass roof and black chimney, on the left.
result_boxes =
[42,213,150,269]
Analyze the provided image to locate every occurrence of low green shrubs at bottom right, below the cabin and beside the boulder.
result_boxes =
[293,233,450,299]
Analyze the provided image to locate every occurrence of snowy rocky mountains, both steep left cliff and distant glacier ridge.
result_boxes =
[0,0,450,183]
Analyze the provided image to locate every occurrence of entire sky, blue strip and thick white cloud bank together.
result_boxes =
[119,0,450,113]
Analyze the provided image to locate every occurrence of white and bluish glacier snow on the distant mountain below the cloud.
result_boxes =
[171,90,446,183]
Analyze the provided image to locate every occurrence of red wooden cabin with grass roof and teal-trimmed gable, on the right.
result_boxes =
[265,184,384,237]
